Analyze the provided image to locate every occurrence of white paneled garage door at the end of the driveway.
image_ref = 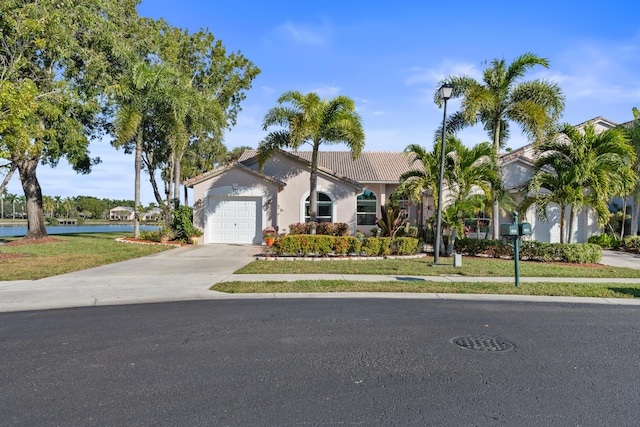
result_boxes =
[206,197,262,243]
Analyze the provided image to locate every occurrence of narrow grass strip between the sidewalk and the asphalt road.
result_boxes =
[211,280,640,298]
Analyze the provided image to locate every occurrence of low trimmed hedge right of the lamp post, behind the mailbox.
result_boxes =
[455,238,602,263]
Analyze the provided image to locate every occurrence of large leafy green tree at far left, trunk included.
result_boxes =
[0,0,137,239]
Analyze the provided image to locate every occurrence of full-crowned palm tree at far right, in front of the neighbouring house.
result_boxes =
[520,124,636,243]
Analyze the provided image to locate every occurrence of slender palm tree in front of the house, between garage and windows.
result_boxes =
[257,91,364,234]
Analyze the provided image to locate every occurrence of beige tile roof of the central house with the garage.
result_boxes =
[238,150,415,183]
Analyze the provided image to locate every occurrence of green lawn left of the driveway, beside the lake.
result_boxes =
[0,233,171,281]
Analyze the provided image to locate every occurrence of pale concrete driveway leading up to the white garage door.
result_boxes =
[0,244,262,312]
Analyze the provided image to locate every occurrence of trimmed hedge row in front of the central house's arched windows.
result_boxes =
[271,234,418,256]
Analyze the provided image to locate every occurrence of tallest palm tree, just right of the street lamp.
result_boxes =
[434,53,564,237]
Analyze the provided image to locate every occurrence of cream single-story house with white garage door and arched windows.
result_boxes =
[185,150,417,244]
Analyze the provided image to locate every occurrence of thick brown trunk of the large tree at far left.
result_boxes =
[17,159,47,239]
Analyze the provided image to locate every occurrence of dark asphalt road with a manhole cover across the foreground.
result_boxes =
[0,299,640,426]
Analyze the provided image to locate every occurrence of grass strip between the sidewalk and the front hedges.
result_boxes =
[236,257,640,278]
